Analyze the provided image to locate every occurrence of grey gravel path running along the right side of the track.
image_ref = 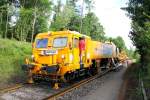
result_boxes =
[57,68,126,100]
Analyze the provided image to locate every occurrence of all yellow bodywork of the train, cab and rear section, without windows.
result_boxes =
[28,31,121,80]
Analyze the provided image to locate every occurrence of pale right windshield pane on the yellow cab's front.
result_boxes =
[53,37,67,48]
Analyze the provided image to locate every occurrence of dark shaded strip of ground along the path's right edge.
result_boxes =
[124,63,143,100]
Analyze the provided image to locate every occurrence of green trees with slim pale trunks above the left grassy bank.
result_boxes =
[0,0,52,41]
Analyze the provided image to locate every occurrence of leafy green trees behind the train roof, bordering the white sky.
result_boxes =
[67,0,104,41]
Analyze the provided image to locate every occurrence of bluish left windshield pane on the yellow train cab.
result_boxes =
[36,38,48,48]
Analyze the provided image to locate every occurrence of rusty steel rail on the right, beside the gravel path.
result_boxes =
[43,70,110,100]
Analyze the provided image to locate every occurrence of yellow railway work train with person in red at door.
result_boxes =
[22,30,127,88]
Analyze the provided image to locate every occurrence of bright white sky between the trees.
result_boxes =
[93,0,133,48]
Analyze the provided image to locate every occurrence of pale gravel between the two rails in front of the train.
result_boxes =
[0,85,61,100]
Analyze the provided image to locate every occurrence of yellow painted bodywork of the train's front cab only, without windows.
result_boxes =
[32,31,91,76]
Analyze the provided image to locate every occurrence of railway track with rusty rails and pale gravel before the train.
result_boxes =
[0,70,110,100]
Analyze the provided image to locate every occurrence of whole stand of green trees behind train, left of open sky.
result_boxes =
[0,0,104,42]
